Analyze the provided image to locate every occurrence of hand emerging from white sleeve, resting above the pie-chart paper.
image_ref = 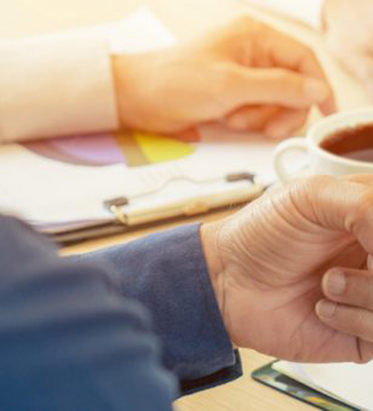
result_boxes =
[113,17,334,138]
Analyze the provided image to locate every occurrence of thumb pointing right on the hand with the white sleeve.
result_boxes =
[230,66,332,112]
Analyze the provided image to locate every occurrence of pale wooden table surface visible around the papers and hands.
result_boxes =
[4,0,368,411]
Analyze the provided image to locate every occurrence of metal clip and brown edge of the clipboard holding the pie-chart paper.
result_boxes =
[48,172,265,245]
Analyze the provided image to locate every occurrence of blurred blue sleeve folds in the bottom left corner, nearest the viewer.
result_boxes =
[0,217,177,411]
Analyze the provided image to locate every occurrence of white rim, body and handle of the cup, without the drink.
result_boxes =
[274,108,373,181]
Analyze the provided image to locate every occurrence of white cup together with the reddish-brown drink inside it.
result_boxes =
[275,108,373,181]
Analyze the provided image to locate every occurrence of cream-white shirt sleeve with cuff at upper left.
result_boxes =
[0,33,119,142]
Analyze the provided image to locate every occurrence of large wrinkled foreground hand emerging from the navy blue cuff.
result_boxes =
[202,176,373,362]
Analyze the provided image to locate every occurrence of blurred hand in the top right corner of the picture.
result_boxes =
[324,0,373,100]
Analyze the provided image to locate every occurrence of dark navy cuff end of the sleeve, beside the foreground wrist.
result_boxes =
[74,225,242,394]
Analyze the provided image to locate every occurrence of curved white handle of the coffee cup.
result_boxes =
[274,137,308,182]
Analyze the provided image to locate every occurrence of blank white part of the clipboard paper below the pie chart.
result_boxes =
[0,137,273,227]
